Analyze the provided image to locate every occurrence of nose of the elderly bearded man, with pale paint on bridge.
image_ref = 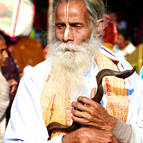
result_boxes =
[63,25,74,43]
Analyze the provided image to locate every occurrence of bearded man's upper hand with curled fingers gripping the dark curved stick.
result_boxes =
[72,97,117,131]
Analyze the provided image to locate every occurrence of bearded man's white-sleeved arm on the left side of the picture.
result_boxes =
[3,76,48,143]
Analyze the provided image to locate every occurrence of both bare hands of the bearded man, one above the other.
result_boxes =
[63,89,118,143]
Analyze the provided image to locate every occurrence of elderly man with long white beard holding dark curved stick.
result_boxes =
[3,0,143,143]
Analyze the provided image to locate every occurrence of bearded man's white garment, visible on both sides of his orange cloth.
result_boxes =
[2,47,143,143]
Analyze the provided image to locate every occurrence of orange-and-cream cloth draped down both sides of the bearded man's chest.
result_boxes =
[40,54,129,137]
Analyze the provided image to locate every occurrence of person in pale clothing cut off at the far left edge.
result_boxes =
[0,35,9,142]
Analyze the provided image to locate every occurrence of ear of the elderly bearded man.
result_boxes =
[96,18,104,38]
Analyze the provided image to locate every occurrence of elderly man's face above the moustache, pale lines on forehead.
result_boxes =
[55,0,92,45]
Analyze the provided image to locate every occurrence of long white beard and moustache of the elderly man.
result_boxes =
[48,37,100,101]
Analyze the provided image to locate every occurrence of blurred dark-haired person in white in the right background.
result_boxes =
[114,29,136,58]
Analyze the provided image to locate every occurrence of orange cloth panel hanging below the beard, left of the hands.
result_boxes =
[40,74,71,136]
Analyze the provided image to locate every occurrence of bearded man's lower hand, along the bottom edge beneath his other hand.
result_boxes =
[62,128,115,143]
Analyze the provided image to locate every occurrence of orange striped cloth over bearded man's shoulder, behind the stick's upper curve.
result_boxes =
[96,54,129,122]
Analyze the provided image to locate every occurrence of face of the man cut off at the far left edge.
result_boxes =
[0,39,8,67]
